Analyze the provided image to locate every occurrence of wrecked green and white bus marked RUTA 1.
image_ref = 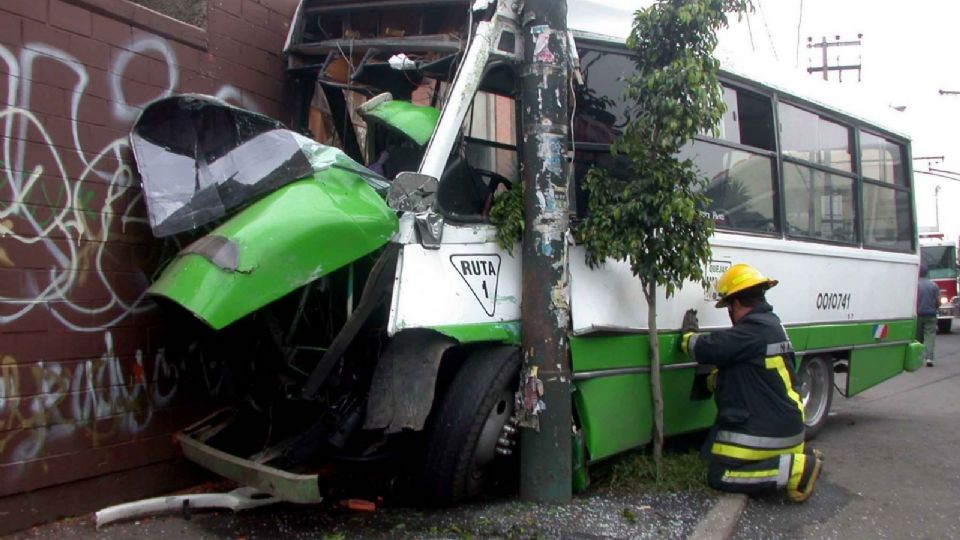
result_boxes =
[131,0,919,504]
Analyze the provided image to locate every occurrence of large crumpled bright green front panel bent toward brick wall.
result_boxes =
[153,168,397,329]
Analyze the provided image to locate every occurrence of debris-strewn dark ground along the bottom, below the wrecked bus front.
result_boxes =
[6,489,715,540]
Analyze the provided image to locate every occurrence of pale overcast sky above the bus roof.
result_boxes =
[568,0,960,240]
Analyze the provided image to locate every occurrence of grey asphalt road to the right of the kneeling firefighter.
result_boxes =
[733,330,960,540]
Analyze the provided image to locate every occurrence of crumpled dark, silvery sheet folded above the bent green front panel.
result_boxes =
[130,95,387,236]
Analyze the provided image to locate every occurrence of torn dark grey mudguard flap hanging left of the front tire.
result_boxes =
[363,328,457,433]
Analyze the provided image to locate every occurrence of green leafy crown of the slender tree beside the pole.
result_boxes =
[578,0,748,296]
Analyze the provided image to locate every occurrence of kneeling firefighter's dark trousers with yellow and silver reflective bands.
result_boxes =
[707,453,816,494]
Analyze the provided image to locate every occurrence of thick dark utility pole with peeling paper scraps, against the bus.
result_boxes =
[519,0,572,503]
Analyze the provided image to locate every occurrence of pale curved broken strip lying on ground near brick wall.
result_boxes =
[94,487,280,529]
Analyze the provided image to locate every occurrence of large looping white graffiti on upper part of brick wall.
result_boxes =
[0,38,248,332]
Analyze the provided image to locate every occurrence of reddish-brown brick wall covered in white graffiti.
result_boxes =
[0,0,297,530]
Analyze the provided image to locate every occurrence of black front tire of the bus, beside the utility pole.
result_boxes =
[419,347,520,506]
